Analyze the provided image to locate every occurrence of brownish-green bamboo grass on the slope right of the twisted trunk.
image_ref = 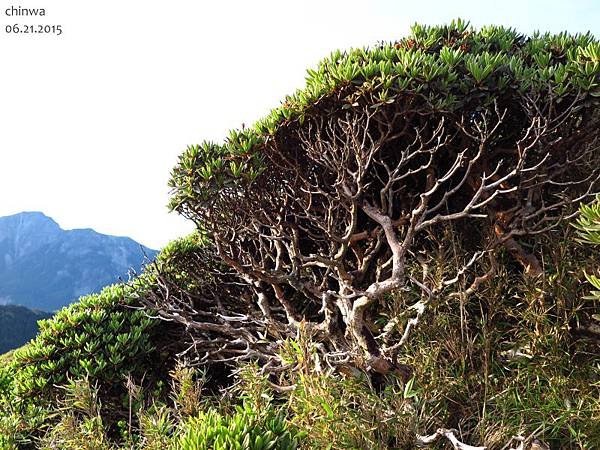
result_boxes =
[380,226,600,449]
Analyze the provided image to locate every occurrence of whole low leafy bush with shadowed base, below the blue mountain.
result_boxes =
[0,241,190,448]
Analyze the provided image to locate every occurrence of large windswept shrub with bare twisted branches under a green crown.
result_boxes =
[163,21,600,372]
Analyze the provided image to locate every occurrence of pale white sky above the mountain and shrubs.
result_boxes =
[0,0,600,248]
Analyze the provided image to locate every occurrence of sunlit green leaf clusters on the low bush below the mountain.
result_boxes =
[13,281,154,396]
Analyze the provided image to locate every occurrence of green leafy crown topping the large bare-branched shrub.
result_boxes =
[170,19,600,216]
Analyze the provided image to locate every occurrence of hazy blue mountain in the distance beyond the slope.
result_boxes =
[0,212,157,311]
